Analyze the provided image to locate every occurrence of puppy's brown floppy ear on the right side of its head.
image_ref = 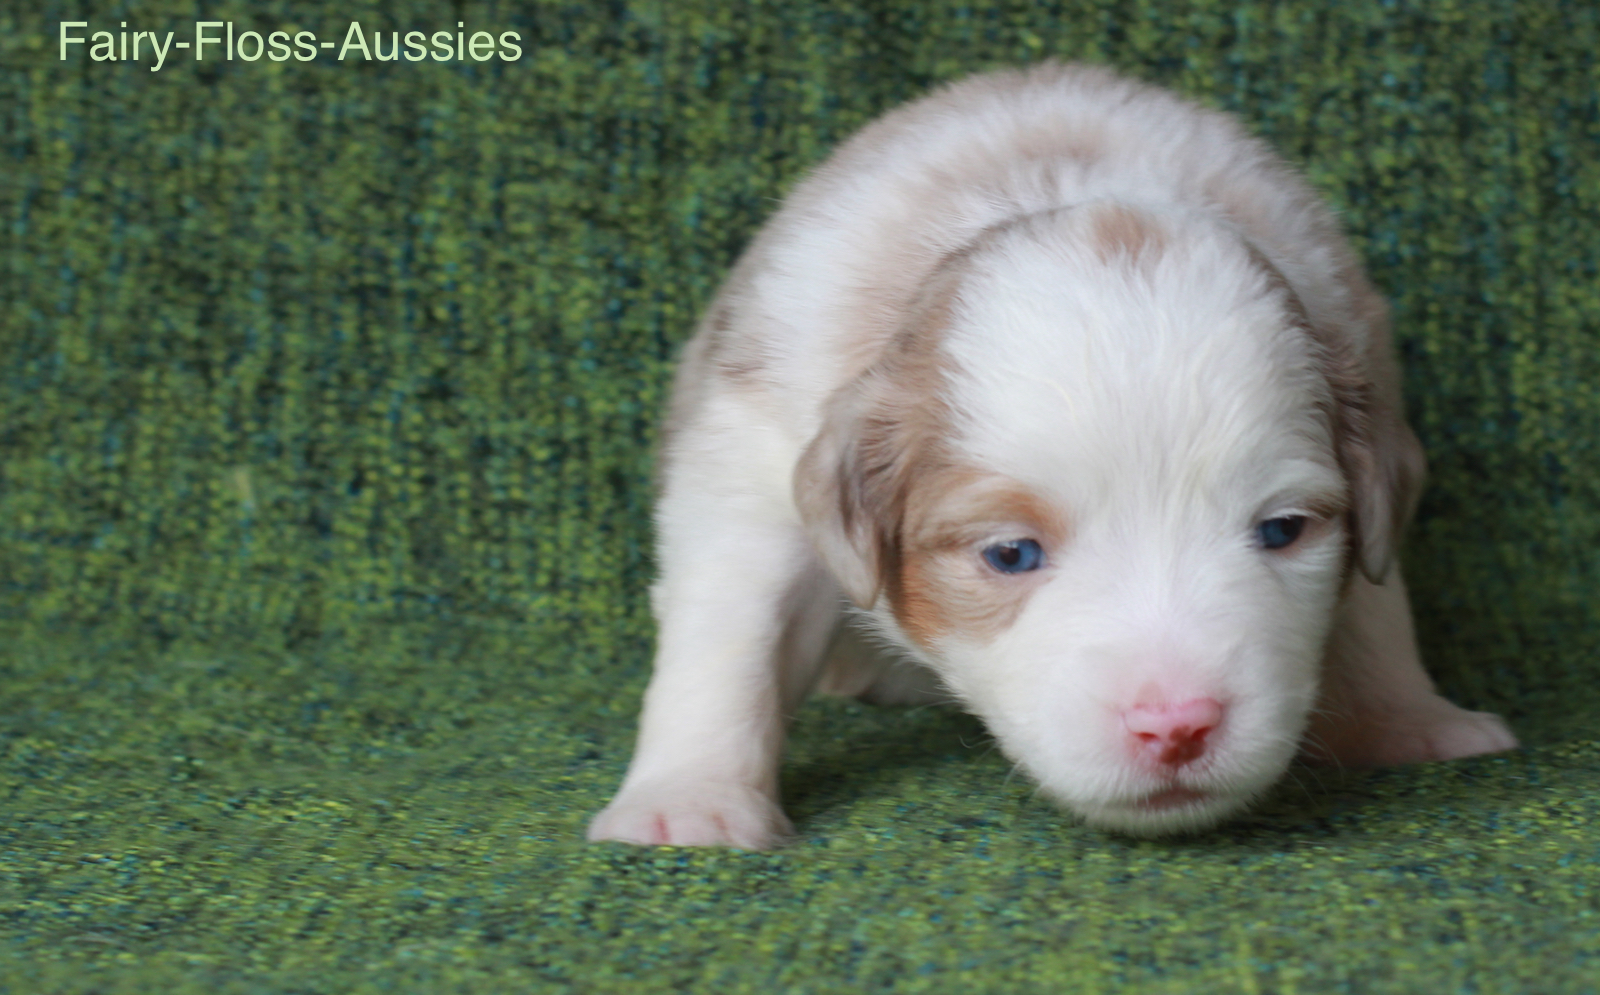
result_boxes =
[1330,286,1427,584]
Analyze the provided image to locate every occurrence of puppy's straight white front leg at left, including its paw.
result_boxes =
[589,499,842,849]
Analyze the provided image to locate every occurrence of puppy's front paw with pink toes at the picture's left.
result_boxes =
[589,784,794,849]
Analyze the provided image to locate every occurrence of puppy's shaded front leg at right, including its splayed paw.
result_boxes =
[1306,565,1517,766]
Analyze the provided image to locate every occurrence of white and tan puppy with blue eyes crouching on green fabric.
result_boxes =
[589,66,1517,849]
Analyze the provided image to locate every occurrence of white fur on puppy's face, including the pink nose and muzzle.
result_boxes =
[914,208,1346,832]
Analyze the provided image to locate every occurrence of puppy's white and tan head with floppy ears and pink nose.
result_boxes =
[795,203,1410,833]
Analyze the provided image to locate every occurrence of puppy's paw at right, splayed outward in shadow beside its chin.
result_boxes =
[1306,699,1518,766]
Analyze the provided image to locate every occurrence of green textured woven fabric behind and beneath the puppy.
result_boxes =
[0,0,1600,993]
